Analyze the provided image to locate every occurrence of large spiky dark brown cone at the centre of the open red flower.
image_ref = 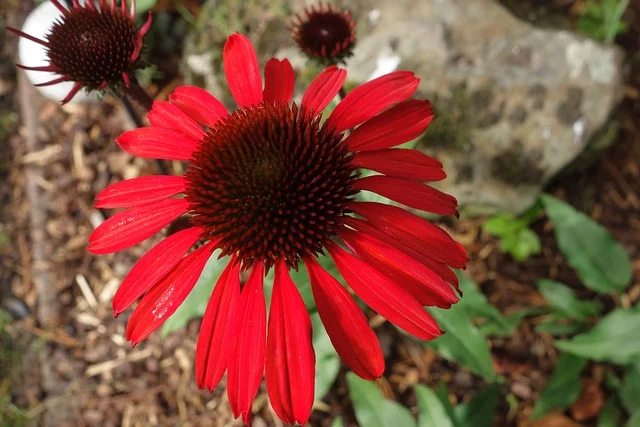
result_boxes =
[186,102,355,267]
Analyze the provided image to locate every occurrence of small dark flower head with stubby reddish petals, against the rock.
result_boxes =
[291,3,356,64]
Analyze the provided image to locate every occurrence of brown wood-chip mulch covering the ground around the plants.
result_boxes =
[0,0,640,426]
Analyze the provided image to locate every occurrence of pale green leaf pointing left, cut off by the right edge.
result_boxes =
[555,309,640,365]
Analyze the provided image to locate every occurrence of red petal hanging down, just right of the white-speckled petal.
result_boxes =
[196,257,240,390]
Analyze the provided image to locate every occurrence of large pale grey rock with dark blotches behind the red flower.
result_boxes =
[182,0,623,215]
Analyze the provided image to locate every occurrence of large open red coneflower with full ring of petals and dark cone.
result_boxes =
[88,34,467,424]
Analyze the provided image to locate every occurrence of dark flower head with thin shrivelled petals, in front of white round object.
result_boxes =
[7,0,151,104]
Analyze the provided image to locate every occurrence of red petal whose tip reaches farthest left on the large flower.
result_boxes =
[87,199,189,254]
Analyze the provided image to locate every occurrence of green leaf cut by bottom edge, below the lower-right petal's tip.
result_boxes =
[347,371,416,427]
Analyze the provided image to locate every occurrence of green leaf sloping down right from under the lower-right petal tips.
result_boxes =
[426,305,495,382]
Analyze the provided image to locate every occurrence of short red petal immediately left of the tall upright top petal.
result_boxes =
[169,86,229,127]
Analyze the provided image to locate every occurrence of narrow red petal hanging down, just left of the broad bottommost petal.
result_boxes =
[227,263,267,423]
